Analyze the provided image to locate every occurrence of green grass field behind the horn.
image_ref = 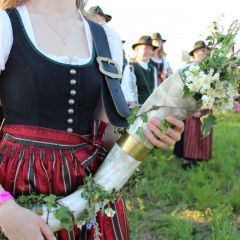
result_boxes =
[126,111,240,240]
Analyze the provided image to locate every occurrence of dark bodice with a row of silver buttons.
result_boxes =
[0,9,101,135]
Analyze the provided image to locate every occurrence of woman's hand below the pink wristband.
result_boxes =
[0,200,56,240]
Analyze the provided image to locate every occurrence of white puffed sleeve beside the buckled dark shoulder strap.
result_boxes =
[103,25,123,72]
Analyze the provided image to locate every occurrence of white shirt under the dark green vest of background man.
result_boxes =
[121,59,157,102]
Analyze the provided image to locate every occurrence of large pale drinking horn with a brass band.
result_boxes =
[38,70,202,231]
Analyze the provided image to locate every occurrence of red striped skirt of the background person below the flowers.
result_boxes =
[183,110,212,160]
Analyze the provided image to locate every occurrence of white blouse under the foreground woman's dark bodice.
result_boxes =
[0,5,123,73]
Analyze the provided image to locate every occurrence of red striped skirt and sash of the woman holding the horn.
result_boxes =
[0,121,130,240]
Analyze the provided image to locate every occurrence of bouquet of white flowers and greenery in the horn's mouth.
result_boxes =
[181,21,240,136]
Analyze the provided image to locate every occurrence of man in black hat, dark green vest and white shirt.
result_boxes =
[122,36,157,106]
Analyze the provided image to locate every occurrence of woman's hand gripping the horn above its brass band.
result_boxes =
[146,116,184,148]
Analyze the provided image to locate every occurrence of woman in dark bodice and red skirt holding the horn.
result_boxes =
[0,0,184,240]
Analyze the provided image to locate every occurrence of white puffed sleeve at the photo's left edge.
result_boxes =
[0,9,13,73]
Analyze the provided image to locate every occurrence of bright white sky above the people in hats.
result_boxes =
[86,0,240,70]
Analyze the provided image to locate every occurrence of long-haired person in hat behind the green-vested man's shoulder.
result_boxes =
[150,33,168,85]
